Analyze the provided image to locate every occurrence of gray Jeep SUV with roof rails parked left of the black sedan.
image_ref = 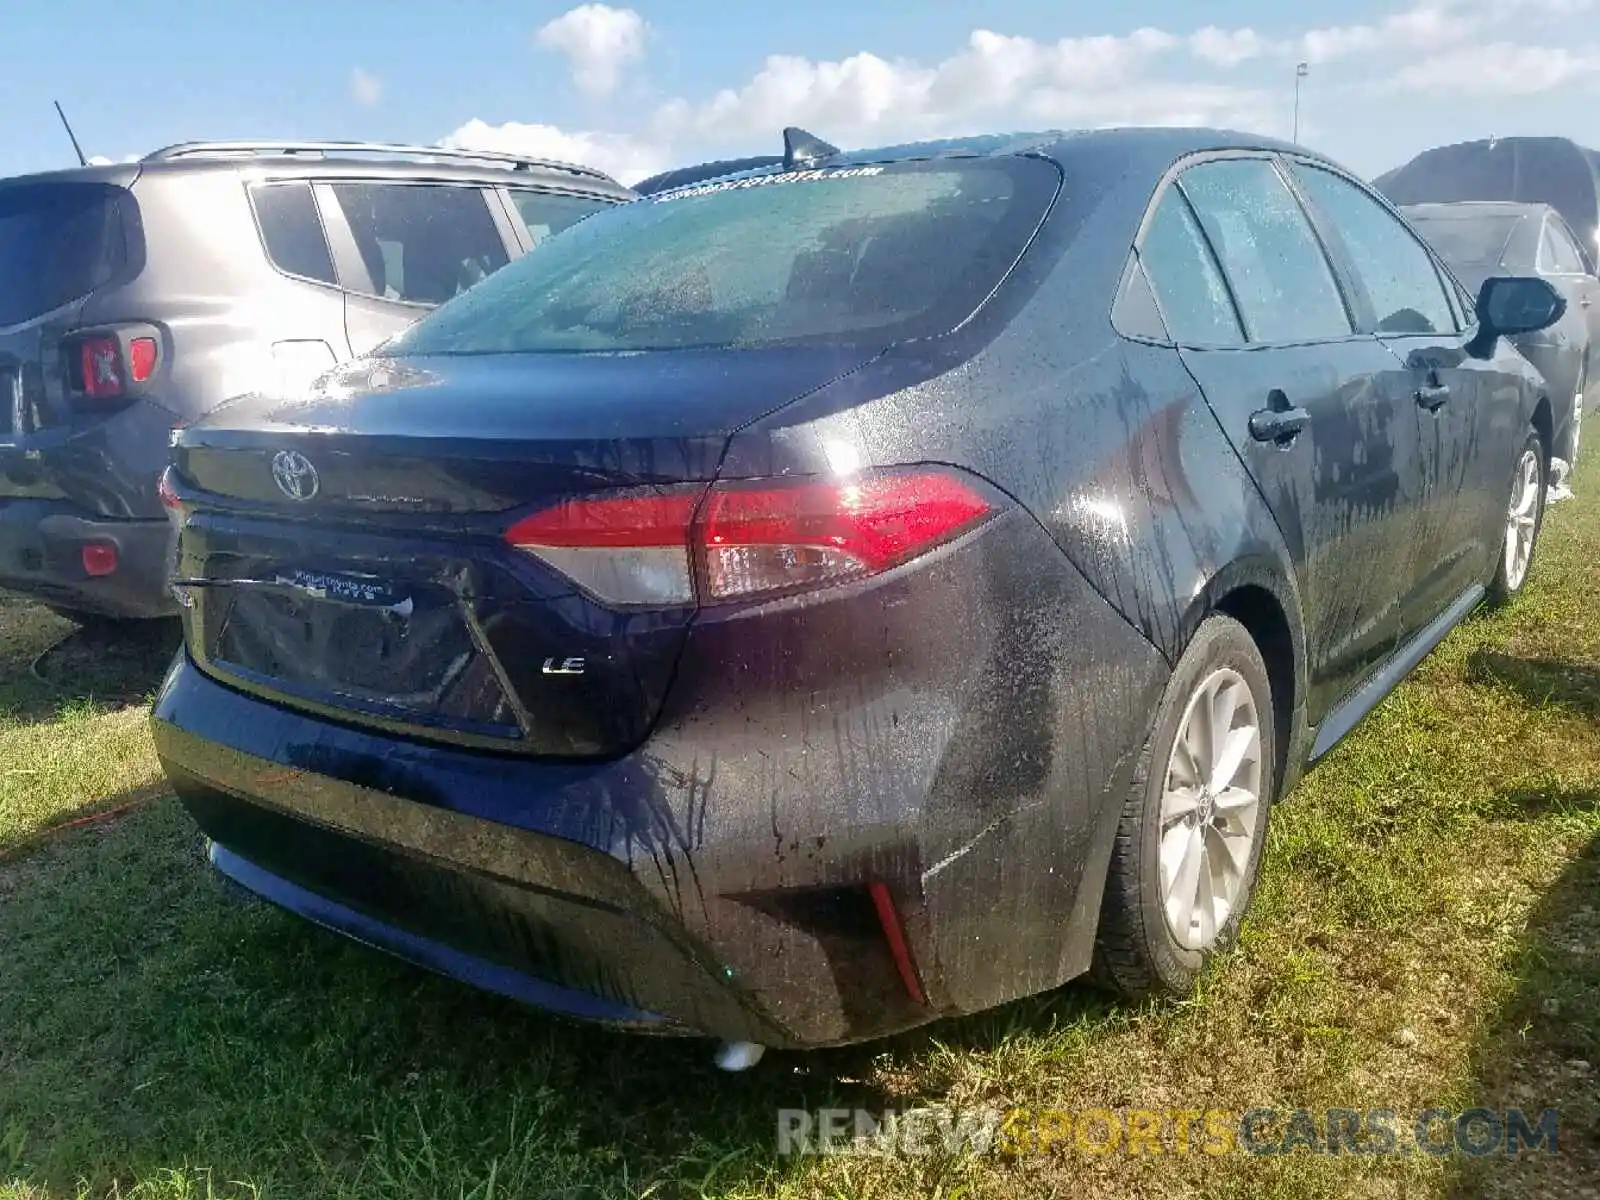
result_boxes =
[0,142,634,618]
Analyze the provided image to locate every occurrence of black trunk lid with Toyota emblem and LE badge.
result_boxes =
[174,350,872,757]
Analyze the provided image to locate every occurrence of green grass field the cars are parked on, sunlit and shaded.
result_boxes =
[0,458,1600,1200]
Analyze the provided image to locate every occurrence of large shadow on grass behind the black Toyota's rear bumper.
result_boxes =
[0,798,947,1198]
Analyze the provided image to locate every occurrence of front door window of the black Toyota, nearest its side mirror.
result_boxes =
[1294,163,1459,334]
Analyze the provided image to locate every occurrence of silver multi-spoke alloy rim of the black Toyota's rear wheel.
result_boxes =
[1157,667,1262,950]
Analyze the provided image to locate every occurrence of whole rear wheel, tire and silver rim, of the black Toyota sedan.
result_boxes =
[1098,616,1277,998]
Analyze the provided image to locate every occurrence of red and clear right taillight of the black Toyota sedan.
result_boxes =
[506,470,994,606]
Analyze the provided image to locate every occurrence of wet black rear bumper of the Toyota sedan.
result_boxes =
[154,518,1166,1046]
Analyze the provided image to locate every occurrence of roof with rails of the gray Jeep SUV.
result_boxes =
[0,142,634,200]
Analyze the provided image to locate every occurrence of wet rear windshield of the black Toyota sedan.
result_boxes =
[395,157,1061,354]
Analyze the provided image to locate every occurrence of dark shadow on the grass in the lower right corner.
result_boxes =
[1448,825,1600,1200]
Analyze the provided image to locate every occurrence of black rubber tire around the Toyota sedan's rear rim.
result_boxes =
[1096,614,1277,1000]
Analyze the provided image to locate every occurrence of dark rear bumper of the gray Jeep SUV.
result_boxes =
[0,498,178,618]
